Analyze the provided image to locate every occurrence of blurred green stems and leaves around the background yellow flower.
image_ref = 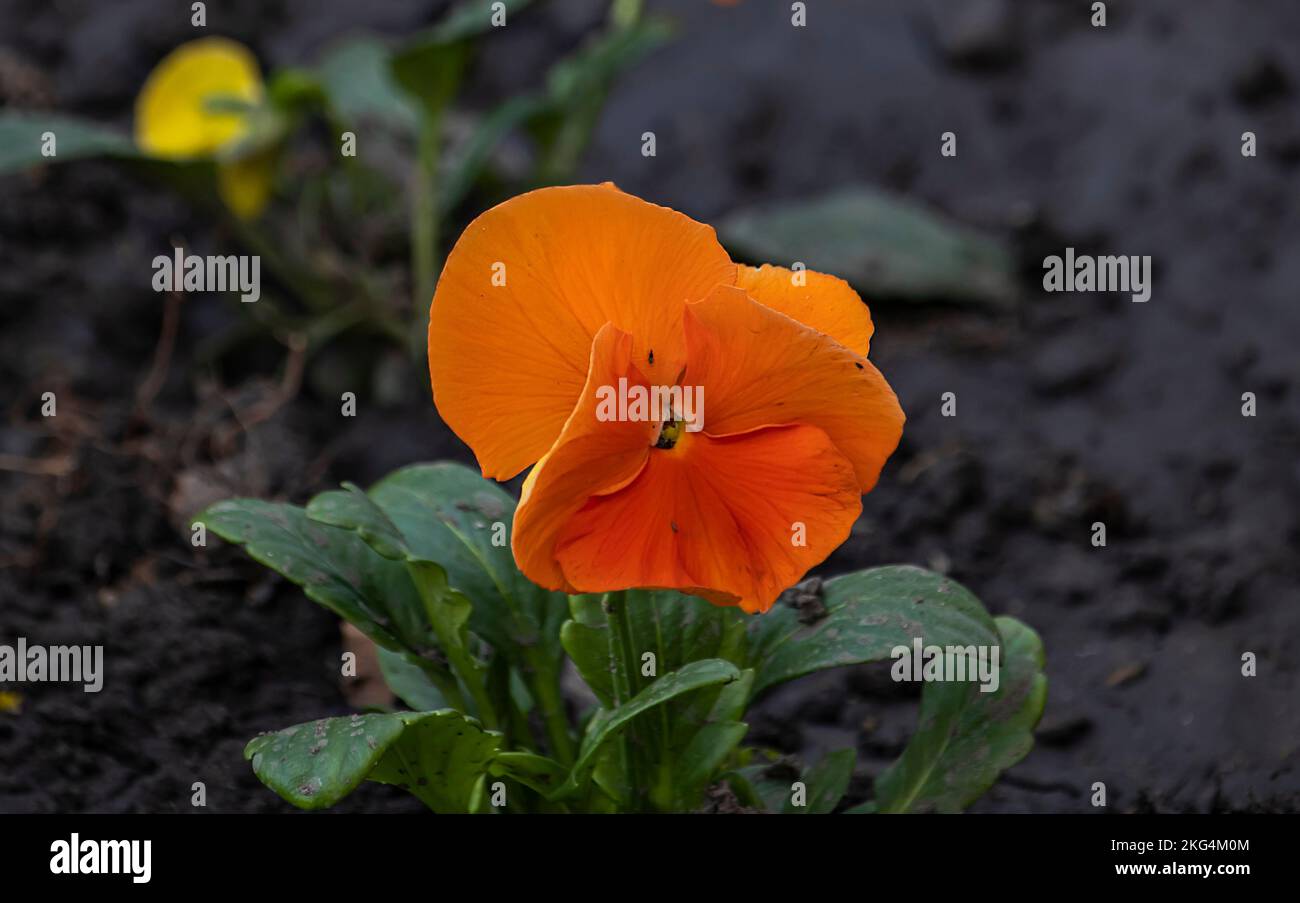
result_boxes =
[0,0,672,359]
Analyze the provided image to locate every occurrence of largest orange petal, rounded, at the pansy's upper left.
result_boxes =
[429,183,736,479]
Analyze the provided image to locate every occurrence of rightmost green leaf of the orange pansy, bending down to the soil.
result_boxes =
[875,617,1048,812]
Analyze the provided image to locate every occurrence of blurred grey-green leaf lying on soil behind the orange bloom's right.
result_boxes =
[718,186,1017,305]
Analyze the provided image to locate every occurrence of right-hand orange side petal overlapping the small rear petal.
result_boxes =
[684,286,905,492]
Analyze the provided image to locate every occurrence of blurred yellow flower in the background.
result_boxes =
[135,38,272,218]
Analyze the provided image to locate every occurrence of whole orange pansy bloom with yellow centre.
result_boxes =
[429,183,904,612]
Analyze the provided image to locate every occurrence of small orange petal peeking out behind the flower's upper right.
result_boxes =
[736,264,875,357]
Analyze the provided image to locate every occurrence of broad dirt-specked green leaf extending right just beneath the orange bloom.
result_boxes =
[748,565,998,694]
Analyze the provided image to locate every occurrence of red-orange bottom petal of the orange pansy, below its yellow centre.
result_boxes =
[551,426,862,612]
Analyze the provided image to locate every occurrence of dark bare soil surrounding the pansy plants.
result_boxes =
[0,0,1300,812]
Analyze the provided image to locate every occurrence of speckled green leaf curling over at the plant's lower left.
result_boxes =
[244,709,501,812]
